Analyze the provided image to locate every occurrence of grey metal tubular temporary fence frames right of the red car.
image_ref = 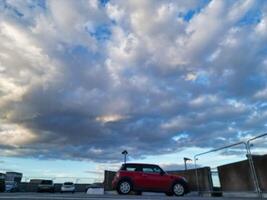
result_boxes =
[194,133,267,198]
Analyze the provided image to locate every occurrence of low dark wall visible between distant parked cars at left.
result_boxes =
[19,182,91,192]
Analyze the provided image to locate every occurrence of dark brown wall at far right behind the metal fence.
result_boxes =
[218,155,267,192]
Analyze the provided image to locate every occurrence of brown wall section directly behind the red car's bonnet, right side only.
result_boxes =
[168,167,213,191]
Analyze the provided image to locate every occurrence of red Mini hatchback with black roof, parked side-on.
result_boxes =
[112,163,189,196]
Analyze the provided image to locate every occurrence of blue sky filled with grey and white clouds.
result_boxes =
[0,0,267,179]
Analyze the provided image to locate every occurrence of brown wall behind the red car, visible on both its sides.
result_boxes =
[104,167,213,191]
